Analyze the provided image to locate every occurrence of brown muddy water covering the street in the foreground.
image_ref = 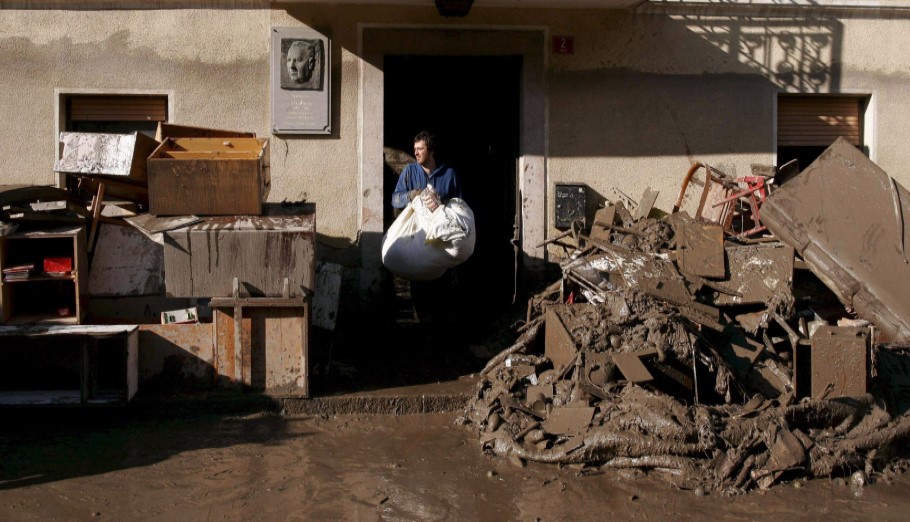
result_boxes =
[0,411,910,521]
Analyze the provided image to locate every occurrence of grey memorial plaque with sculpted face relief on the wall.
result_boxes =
[270,27,332,134]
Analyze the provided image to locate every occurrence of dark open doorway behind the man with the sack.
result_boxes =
[383,55,522,340]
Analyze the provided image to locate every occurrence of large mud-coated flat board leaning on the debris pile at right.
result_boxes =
[762,138,910,342]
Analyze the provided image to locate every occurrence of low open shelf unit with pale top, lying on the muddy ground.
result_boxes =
[0,325,139,406]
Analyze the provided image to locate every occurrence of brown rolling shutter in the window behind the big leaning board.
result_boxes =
[777,95,865,147]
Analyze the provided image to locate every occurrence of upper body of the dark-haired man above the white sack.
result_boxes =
[392,131,462,212]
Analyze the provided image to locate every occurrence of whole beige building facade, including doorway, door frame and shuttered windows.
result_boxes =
[0,0,910,320]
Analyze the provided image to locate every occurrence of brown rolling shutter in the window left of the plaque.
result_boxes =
[67,95,167,122]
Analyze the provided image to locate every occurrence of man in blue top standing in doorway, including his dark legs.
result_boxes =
[383,131,473,350]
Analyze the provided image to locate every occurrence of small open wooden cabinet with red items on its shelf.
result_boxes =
[0,227,88,324]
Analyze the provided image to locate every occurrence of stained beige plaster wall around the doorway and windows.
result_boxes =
[0,3,910,264]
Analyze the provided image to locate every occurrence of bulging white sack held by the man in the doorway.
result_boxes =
[382,192,476,281]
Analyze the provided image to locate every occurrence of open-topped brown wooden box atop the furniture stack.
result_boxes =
[148,138,271,216]
